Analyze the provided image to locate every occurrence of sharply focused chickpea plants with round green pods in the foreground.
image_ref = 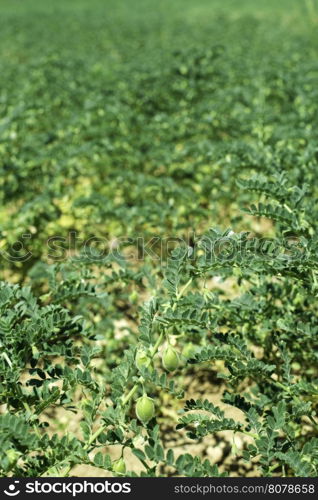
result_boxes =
[0,176,318,476]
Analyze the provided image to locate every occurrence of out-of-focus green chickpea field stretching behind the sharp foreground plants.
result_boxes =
[0,0,317,281]
